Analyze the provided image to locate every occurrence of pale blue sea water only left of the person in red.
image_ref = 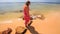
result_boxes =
[0,2,24,12]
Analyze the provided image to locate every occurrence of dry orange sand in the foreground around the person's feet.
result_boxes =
[0,12,60,34]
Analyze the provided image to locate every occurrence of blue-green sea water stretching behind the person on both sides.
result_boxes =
[0,2,60,13]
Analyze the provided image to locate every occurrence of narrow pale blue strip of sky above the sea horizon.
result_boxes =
[0,0,60,2]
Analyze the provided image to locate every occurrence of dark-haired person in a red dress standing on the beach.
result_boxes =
[23,1,30,26]
